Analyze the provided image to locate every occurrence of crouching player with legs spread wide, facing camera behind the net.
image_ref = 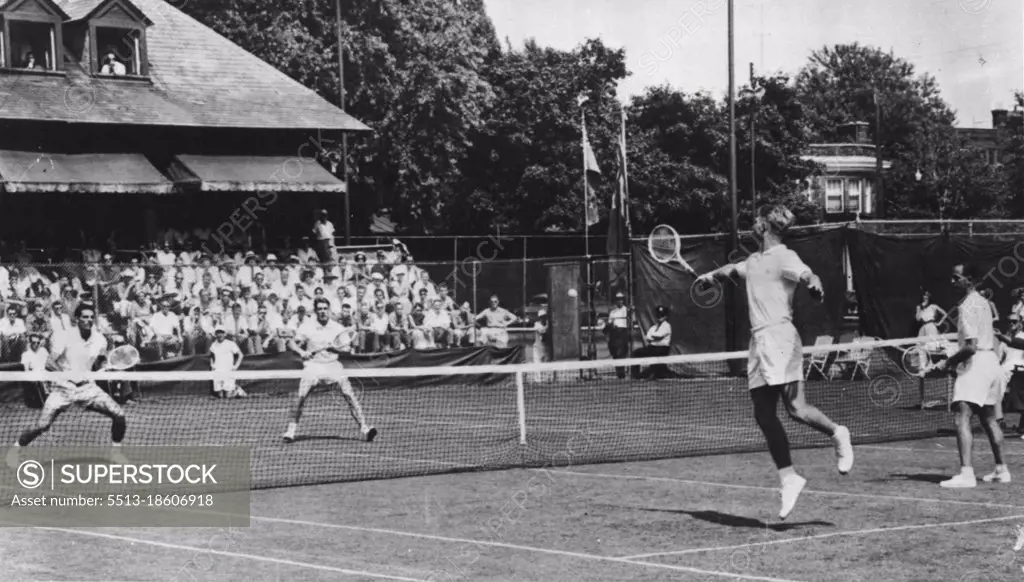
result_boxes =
[283,297,377,443]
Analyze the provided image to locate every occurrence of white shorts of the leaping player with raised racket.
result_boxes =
[746,322,804,390]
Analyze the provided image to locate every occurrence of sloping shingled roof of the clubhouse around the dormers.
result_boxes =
[0,0,370,131]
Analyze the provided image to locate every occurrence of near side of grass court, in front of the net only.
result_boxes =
[0,438,1024,582]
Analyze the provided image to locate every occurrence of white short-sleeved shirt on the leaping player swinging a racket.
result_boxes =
[736,245,811,331]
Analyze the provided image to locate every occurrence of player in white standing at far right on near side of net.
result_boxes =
[936,264,1010,489]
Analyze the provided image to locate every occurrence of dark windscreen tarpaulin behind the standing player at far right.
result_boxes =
[850,231,1024,339]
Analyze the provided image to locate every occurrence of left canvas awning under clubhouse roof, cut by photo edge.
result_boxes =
[0,150,174,194]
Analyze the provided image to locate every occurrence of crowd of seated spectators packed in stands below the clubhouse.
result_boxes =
[0,241,517,363]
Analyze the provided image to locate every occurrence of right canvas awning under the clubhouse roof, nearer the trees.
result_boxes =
[170,155,345,193]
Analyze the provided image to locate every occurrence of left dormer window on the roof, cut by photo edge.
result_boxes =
[0,0,67,72]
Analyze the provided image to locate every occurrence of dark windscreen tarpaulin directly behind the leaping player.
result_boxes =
[633,228,846,374]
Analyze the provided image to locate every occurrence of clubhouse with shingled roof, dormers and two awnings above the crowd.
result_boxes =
[0,0,369,257]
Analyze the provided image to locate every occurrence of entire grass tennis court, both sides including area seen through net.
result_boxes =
[0,344,1024,582]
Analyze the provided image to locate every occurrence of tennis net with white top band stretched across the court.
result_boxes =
[0,338,951,488]
